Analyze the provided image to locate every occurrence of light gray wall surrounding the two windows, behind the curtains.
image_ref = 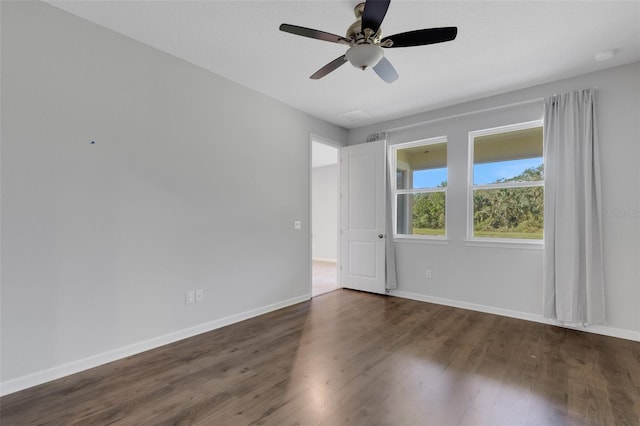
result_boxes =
[349,63,640,340]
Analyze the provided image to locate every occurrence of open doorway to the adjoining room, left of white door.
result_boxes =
[311,139,340,297]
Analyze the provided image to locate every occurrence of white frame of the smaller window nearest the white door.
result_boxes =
[389,136,449,242]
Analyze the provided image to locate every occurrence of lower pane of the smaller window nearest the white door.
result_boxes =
[396,191,446,236]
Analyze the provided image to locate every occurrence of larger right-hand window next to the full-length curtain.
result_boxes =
[468,121,544,240]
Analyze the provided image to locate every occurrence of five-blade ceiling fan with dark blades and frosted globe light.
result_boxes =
[280,0,458,83]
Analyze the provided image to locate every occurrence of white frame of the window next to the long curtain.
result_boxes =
[465,119,545,248]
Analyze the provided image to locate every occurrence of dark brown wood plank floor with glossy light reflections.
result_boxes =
[0,290,640,426]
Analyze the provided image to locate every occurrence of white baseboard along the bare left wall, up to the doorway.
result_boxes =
[0,294,311,396]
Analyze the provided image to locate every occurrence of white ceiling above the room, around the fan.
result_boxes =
[48,0,640,128]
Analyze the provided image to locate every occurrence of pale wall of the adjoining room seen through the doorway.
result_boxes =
[311,164,339,262]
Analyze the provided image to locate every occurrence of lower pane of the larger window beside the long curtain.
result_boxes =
[473,186,544,239]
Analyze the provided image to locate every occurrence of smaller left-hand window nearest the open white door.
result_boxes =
[391,137,447,238]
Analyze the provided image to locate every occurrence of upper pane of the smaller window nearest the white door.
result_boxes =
[396,142,447,189]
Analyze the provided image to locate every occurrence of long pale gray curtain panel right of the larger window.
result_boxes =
[544,89,605,325]
